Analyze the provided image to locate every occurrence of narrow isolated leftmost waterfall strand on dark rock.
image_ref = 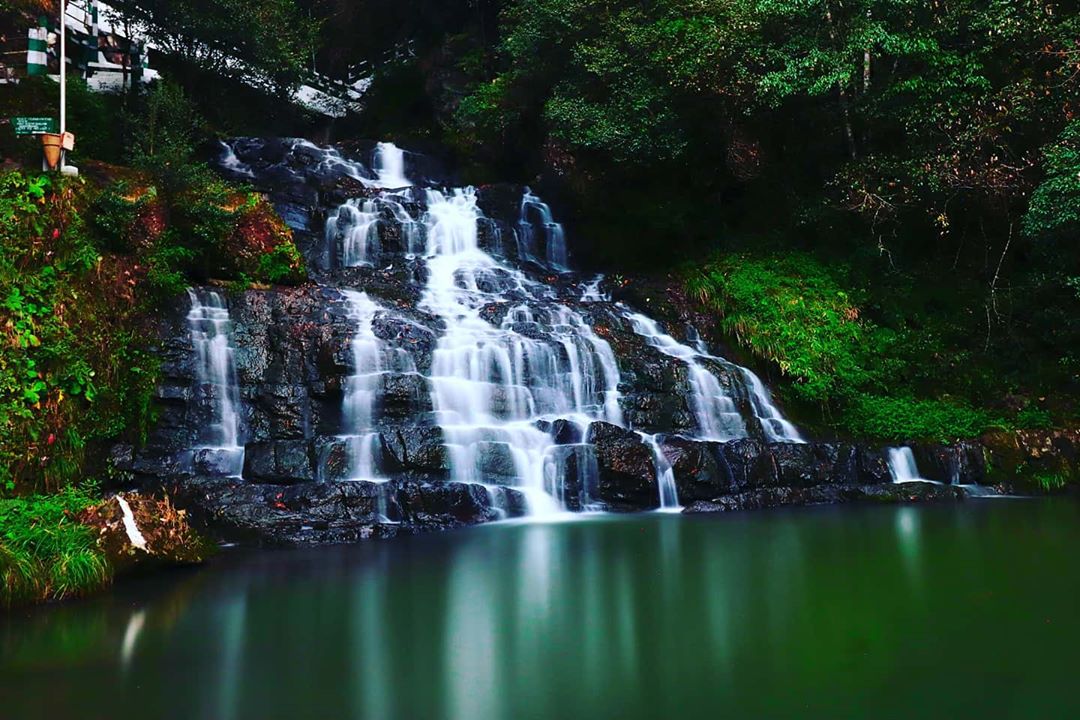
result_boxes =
[188,288,244,477]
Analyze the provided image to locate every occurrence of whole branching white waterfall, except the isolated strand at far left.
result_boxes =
[212,140,801,515]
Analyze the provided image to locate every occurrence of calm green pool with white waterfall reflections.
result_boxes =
[0,502,1080,720]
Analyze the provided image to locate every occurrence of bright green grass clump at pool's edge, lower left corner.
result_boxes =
[0,486,111,607]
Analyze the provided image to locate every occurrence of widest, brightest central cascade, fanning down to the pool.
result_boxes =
[421,188,622,514]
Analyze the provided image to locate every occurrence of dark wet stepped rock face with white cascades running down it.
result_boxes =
[113,140,1002,543]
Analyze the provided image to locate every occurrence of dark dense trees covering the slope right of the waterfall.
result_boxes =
[434,0,1080,435]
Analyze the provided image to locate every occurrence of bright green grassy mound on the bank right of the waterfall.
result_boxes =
[685,254,1036,441]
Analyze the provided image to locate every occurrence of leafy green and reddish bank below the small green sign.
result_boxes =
[0,173,157,491]
